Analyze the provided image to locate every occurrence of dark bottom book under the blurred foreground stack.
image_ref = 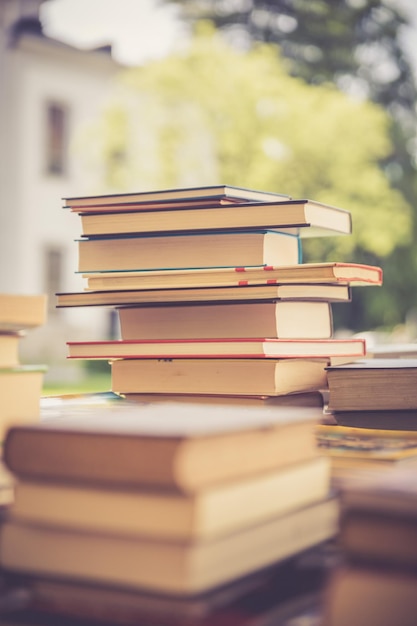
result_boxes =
[4,546,327,626]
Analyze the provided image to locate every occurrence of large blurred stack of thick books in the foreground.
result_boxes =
[0,399,338,626]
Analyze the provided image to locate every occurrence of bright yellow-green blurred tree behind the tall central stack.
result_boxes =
[88,26,411,327]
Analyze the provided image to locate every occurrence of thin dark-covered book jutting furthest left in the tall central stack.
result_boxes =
[56,283,351,307]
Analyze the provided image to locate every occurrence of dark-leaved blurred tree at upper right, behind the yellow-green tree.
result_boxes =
[172,0,417,332]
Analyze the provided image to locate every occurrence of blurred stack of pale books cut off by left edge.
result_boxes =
[0,293,46,505]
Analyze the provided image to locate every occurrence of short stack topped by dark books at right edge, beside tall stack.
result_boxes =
[316,358,417,483]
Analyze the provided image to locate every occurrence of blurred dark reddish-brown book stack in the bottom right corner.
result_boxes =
[322,470,417,626]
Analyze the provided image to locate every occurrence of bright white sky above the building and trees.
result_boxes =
[41,0,417,75]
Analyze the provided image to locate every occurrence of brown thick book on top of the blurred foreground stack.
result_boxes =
[4,400,322,492]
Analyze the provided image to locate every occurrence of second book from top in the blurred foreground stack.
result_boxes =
[12,457,330,541]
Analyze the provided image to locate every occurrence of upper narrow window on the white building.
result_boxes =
[46,102,68,174]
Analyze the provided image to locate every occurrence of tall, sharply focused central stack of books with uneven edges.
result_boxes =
[57,186,382,399]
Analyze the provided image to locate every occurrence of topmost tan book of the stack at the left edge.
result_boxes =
[0,293,47,332]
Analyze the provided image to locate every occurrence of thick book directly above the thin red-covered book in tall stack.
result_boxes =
[117,300,333,340]
